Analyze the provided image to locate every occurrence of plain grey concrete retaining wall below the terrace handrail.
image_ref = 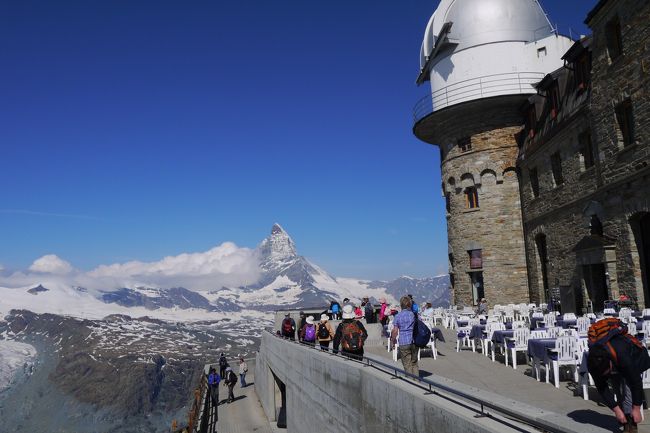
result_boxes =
[255,332,601,433]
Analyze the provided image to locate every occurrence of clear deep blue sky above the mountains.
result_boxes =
[0,0,595,278]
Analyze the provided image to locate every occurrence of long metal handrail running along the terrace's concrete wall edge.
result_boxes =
[266,329,566,433]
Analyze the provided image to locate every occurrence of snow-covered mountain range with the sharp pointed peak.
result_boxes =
[0,224,449,320]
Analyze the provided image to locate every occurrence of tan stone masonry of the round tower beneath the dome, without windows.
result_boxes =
[442,120,529,305]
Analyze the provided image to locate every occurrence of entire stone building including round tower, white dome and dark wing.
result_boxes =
[413,0,650,312]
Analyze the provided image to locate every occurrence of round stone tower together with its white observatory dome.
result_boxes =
[413,0,573,305]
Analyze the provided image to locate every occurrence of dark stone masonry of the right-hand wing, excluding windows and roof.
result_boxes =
[518,0,650,312]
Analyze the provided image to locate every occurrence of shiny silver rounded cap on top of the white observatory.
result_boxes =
[420,0,553,67]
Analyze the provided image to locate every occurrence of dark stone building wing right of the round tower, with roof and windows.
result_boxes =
[517,0,650,312]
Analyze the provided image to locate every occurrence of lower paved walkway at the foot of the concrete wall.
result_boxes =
[217,360,280,433]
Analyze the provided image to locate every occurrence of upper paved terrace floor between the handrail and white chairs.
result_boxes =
[366,329,650,433]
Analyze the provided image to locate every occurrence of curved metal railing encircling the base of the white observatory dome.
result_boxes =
[413,72,546,123]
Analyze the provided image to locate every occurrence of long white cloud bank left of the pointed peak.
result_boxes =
[0,242,260,290]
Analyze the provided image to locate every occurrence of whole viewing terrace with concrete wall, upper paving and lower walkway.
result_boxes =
[185,306,650,433]
